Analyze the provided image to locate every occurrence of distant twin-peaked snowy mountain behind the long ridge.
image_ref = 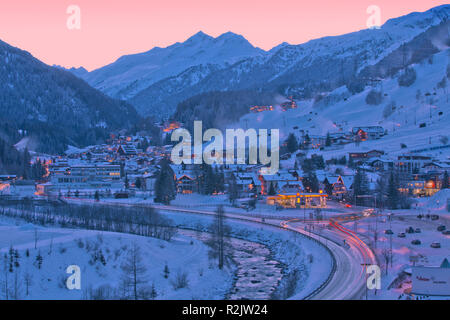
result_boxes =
[82,31,265,99]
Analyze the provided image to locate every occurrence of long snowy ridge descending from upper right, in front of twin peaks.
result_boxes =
[126,5,450,116]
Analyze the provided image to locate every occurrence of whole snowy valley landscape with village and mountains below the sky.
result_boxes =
[0,1,450,306]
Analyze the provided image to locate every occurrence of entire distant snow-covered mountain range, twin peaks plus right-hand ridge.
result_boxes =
[77,5,450,118]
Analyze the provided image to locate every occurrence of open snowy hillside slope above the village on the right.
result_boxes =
[234,49,450,158]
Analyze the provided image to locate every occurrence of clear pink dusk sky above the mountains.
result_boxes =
[0,0,446,70]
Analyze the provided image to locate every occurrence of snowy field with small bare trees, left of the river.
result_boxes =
[0,217,232,300]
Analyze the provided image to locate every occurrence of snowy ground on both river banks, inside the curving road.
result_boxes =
[0,199,332,299]
